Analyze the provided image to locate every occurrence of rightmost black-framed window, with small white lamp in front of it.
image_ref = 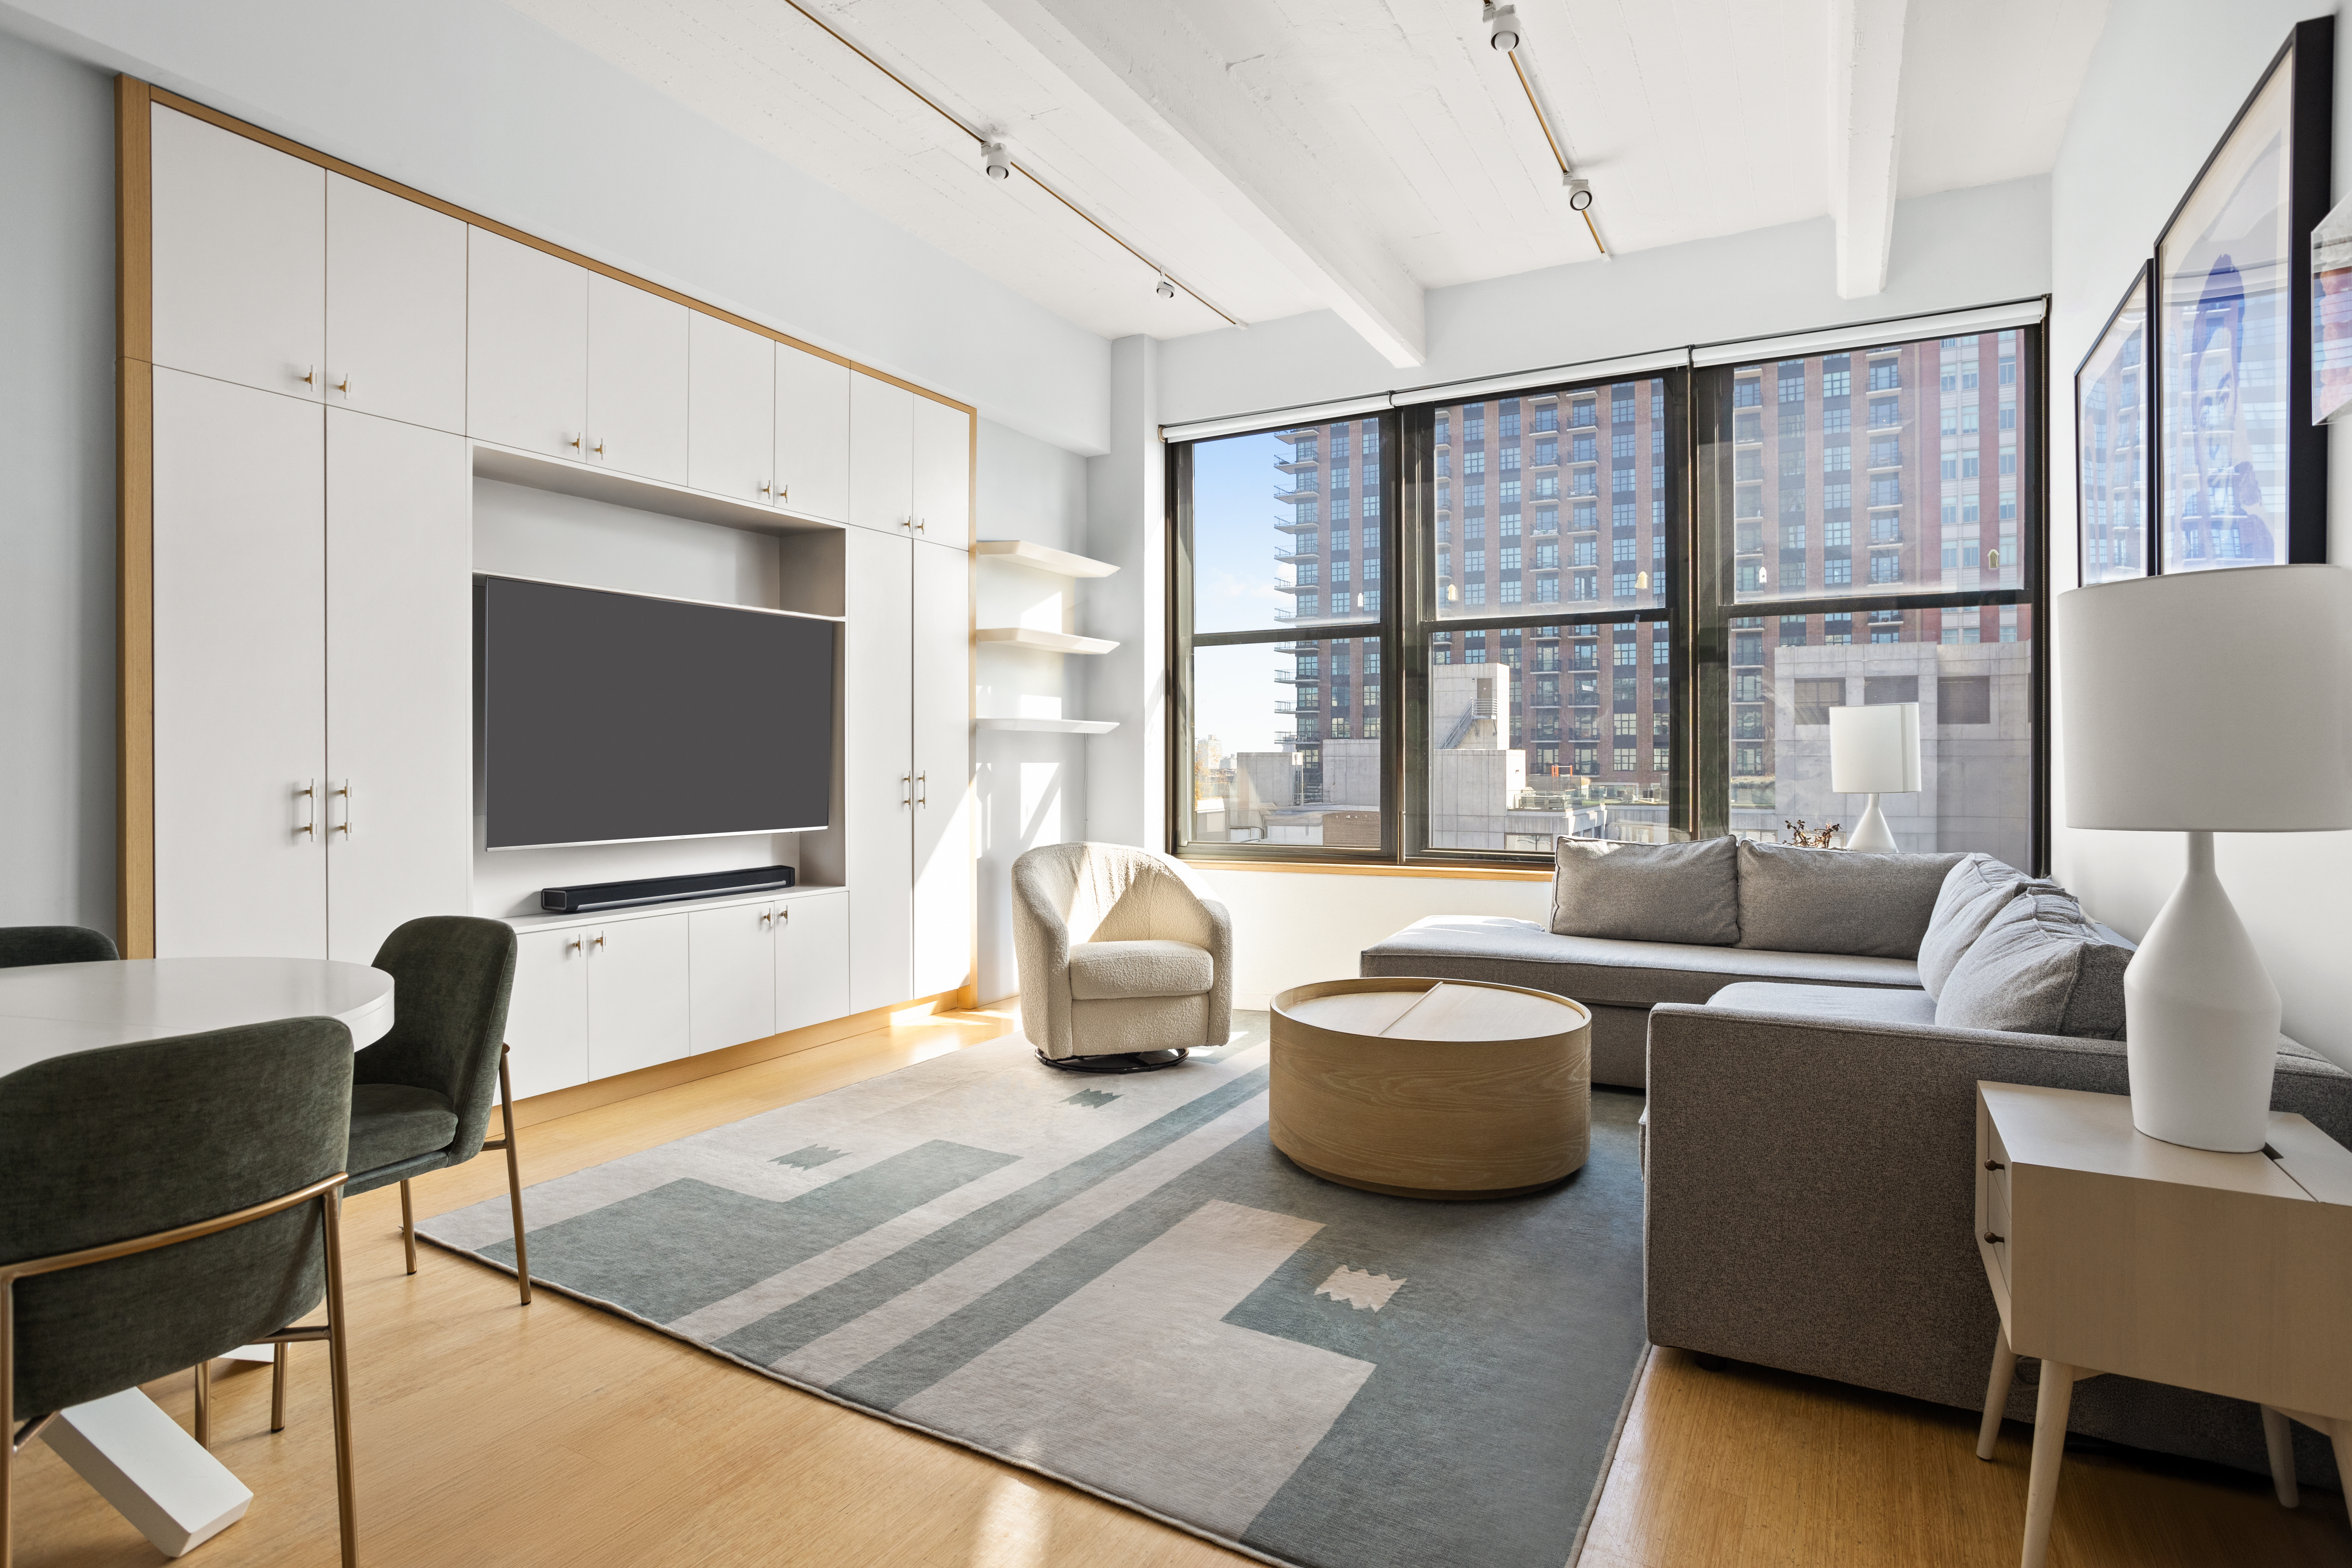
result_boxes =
[1693,329,2042,865]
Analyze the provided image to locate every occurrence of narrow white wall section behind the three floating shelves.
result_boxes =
[971,419,1096,1001]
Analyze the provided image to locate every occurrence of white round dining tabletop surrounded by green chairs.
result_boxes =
[0,959,393,1077]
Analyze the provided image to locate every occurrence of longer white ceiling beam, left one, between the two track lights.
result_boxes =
[964,0,1428,369]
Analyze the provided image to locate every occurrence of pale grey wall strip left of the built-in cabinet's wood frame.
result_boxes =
[0,35,115,933]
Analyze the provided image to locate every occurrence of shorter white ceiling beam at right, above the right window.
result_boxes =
[1830,0,1910,299]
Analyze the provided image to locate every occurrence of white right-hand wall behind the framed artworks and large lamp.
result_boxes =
[2049,0,2352,1067]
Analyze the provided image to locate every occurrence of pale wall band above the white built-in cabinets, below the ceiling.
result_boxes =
[0,0,1105,451]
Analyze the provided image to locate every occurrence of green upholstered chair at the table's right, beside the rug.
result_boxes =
[348,915,532,1307]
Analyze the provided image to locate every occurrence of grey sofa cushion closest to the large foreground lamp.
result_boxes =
[1936,882,2131,1039]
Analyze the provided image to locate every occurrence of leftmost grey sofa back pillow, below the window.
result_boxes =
[1552,837,1741,947]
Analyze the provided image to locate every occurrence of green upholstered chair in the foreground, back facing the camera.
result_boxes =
[0,1018,357,1568]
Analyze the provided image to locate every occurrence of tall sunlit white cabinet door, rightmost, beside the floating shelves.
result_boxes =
[912,538,974,997]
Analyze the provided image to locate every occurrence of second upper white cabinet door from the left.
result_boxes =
[324,174,466,435]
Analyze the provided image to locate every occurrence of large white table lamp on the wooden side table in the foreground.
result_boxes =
[2058,567,2352,1154]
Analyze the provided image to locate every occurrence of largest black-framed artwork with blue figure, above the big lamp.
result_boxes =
[2152,16,2336,571]
